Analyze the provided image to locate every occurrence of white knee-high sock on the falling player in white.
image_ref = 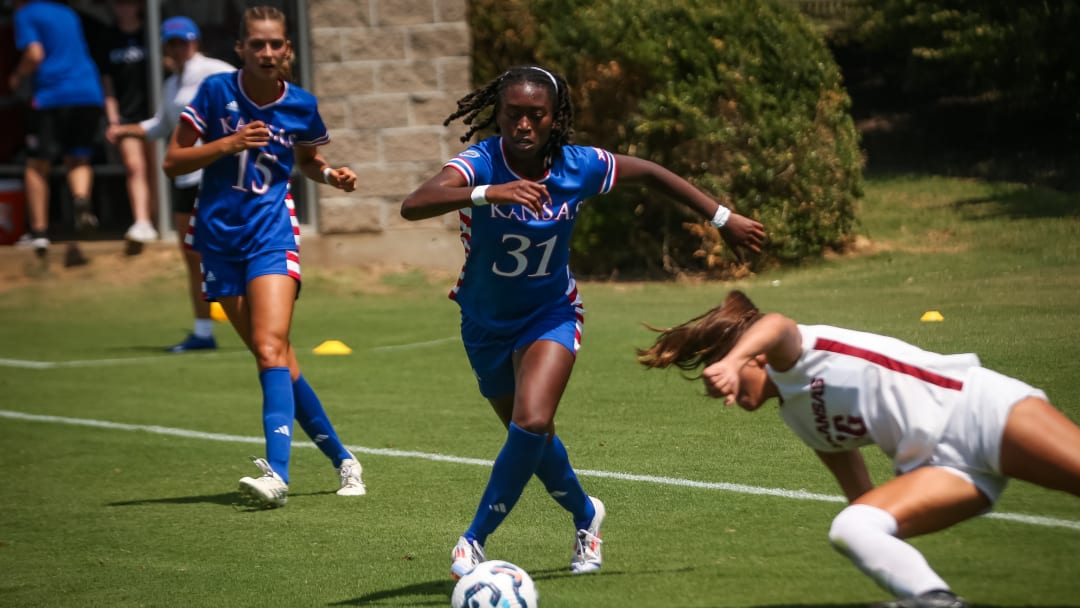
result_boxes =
[828,504,949,597]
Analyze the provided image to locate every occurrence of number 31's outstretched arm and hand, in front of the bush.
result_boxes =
[616,154,765,253]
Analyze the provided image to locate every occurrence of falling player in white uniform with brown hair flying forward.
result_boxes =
[638,292,1080,608]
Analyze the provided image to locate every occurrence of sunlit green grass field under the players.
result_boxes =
[0,177,1080,608]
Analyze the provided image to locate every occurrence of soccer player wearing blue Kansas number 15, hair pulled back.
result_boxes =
[164,6,366,508]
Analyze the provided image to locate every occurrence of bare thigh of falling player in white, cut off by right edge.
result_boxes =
[1001,397,1080,496]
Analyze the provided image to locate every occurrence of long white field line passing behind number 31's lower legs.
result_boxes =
[0,409,1080,530]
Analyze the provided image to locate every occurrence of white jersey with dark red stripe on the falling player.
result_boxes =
[768,325,978,473]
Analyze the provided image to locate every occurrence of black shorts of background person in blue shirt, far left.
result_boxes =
[26,106,102,161]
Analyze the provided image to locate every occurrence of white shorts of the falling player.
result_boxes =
[926,367,1047,504]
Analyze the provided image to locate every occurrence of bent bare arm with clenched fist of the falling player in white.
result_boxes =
[702,312,802,405]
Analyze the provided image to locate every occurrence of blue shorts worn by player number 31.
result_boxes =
[461,306,584,398]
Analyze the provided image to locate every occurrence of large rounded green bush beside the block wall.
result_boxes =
[470,0,862,276]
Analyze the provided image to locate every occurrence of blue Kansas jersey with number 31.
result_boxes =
[446,137,616,333]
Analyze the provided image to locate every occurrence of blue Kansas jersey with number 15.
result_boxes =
[180,70,330,260]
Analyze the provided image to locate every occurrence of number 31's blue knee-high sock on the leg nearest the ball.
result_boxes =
[464,422,548,544]
